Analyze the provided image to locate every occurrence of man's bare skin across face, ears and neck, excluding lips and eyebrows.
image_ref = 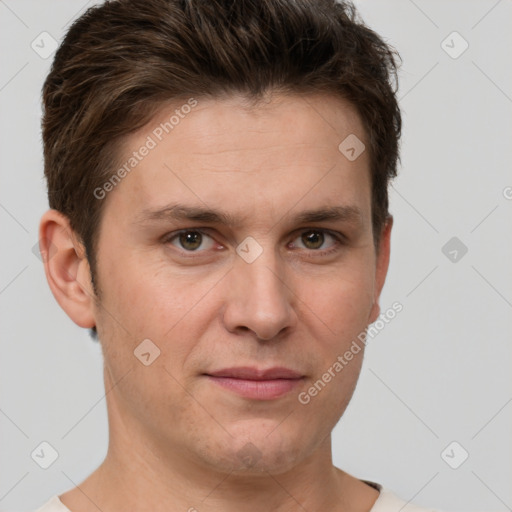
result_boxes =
[40,94,392,512]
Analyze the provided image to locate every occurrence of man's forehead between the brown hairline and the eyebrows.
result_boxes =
[105,95,370,224]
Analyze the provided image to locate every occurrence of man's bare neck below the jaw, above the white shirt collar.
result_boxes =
[61,372,378,512]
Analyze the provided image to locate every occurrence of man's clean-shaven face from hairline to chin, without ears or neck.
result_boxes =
[90,92,389,472]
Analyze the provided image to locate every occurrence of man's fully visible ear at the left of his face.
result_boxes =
[39,210,96,328]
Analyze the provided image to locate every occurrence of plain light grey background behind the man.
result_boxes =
[0,0,512,511]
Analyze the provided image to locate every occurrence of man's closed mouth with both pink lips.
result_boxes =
[204,367,305,400]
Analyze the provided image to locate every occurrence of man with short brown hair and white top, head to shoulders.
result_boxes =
[35,0,440,512]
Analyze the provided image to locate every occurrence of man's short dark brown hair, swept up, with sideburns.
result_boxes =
[42,0,401,288]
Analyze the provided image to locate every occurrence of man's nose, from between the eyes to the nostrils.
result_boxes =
[223,250,295,340]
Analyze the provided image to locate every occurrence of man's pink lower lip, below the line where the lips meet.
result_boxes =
[208,375,302,400]
